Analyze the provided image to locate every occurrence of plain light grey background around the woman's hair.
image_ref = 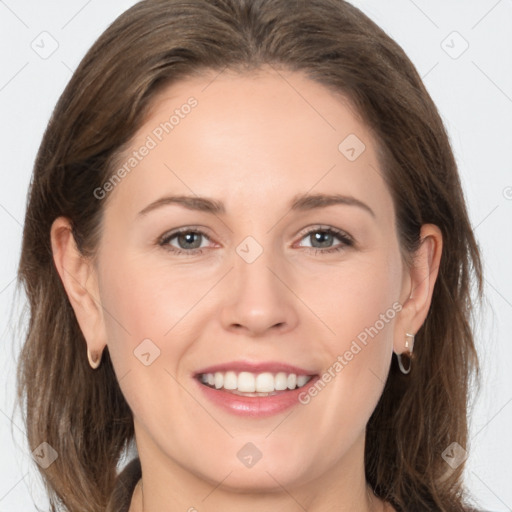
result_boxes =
[0,0,512,512]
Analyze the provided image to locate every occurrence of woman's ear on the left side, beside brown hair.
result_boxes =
[50,217,107,361]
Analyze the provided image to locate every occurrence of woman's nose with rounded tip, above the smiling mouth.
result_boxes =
[221,246,299,337]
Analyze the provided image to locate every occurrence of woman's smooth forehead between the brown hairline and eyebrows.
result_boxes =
[103,68,392,222]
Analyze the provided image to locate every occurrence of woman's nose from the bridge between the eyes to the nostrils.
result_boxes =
[222,236,297,335]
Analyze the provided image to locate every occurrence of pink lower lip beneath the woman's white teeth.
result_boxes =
[194,375,320,418]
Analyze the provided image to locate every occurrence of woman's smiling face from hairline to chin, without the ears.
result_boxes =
[91,70,407,496]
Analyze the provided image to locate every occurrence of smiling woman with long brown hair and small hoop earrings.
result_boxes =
[15,0,482,512]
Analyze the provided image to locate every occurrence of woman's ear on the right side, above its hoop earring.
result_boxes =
[393,224,443,354]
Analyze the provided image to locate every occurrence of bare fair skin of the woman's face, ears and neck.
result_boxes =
[51,68,442,512]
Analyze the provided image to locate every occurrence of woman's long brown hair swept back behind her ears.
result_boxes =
[14,0,482,512]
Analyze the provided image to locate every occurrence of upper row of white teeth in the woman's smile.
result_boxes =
[201,371,311,393]
